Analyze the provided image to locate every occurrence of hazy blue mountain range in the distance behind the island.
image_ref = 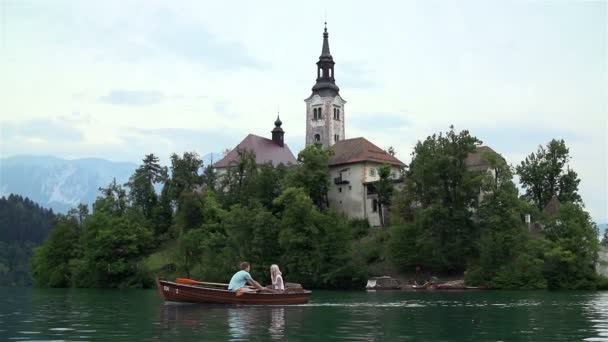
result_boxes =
[0,153,222,213]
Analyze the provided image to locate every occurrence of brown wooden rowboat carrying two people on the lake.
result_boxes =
[156,278,311,305]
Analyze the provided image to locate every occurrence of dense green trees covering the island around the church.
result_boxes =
[32,128,601,289]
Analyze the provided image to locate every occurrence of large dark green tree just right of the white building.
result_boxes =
[391,127,484,272]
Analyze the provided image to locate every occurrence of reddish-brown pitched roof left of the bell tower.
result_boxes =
[214,134,297,168]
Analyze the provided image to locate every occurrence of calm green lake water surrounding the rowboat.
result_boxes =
[0,288,608,342]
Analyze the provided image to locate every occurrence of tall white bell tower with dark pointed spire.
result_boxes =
[304,23,346,147]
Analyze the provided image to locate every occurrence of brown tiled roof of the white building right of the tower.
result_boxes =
[329,138,405,166]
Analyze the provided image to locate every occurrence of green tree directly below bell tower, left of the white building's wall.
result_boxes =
[286,145,333,210]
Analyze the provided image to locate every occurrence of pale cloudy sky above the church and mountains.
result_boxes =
[0,0,608,223]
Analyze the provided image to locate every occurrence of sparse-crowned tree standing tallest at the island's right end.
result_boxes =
[516,139,582,211]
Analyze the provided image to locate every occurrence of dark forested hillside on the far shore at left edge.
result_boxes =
[0,194,55,286]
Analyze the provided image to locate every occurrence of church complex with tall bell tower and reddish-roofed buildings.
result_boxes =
[214,24,405,227]
